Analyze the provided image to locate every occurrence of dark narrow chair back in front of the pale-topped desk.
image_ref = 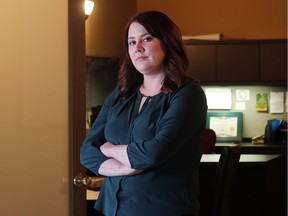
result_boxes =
[211,146,241,216]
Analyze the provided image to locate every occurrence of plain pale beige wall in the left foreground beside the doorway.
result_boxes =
[0,0,68,216]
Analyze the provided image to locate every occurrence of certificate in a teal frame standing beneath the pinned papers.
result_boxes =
[206,111,243,142]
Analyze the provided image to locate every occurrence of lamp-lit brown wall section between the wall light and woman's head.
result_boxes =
[86,0,136,59]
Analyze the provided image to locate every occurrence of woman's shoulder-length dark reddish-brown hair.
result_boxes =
[118,11,189,97]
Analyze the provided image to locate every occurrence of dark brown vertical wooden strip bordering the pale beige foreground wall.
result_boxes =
[68,0,87,216]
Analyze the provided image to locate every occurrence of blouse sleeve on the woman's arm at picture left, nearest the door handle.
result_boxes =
[80,88,118,175]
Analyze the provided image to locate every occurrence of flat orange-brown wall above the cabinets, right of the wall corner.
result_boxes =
[136,0,287,39]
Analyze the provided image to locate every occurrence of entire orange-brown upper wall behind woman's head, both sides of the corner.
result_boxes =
[86,0,287,60]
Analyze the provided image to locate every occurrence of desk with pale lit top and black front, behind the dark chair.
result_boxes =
[199,154,287,216]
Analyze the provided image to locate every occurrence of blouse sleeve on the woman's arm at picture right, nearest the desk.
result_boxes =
[127,82,207,169]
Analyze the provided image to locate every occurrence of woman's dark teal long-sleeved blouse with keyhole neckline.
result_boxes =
[80,80,207,216]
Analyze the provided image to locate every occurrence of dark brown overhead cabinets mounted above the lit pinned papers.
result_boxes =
[184,39,287,85]
